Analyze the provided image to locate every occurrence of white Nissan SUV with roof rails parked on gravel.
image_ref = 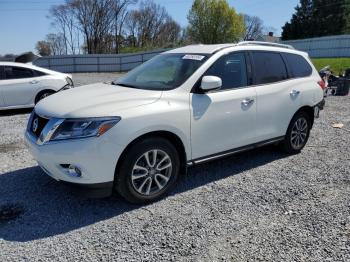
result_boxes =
[25,42,324,203]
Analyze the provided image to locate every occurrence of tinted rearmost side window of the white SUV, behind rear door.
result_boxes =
[283,54,312,78]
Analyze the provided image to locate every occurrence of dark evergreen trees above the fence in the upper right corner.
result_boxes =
[282,0,350,40]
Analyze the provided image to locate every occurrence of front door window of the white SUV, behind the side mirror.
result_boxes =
[205,53,247,90]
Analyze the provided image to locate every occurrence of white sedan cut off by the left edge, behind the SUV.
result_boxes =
[0,62,73,110]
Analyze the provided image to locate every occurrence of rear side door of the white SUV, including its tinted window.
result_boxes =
[250,51,301,141]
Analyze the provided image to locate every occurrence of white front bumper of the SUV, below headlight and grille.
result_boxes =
[25,131,123,195]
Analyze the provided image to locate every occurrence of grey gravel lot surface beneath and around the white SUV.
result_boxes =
[0,74,350,261]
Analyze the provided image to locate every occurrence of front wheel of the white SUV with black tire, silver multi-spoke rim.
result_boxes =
[115,138,180,204]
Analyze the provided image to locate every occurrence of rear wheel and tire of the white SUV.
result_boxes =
[281,111,311,154]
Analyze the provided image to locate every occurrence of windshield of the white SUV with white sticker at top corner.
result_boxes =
[113,54,207,90]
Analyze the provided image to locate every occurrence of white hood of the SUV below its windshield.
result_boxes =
[35,83,162,118]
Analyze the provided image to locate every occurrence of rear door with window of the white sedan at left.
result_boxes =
[1,66,40,106]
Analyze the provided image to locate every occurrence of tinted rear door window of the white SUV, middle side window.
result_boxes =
[253,52,287,85]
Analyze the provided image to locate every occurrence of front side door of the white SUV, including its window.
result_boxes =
[191,52,256,159]
